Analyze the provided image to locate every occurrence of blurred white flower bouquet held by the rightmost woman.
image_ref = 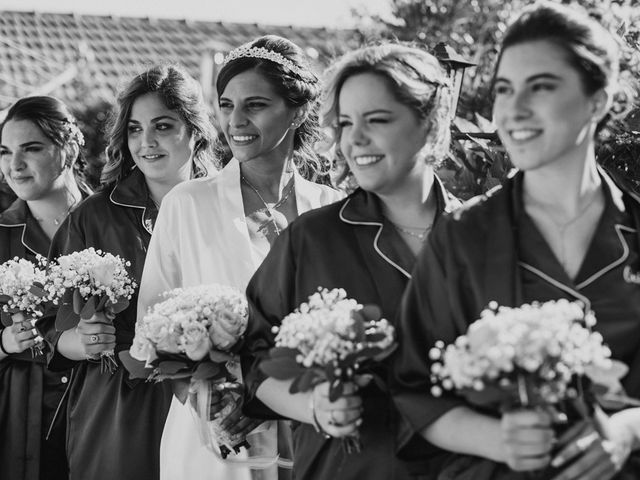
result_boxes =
[429,299,617,409]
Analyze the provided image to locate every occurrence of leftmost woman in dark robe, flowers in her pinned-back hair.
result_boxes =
[0,97,86,480]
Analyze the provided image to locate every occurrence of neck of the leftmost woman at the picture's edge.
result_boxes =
[27,171,82,225]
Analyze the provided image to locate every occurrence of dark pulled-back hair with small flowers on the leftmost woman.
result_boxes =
[0,96,86,183]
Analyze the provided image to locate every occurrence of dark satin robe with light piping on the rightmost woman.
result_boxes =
[392,173,640,480]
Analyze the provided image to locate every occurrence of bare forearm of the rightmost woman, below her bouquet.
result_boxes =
[421,407,505,462]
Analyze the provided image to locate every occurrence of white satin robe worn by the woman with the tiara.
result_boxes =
[138,159,340,480]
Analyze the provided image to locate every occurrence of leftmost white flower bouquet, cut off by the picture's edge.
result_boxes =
[0,255,57,356]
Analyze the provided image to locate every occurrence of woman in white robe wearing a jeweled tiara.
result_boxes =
[138,35,339,479]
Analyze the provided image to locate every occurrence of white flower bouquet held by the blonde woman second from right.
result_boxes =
[260,288,396,452]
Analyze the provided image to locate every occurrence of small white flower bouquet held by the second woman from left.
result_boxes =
[48,247,136,372]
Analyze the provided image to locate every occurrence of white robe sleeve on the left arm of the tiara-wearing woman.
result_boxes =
[137,195,182,320]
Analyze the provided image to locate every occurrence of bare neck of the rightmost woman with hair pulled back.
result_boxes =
[523,143,602,216]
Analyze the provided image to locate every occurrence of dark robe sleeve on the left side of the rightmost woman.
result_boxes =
[391,217,466,457]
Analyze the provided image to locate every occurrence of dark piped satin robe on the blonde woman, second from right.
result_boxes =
[242,182,457,480]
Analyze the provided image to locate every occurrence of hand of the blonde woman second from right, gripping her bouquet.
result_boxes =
[311,382,362,437]
